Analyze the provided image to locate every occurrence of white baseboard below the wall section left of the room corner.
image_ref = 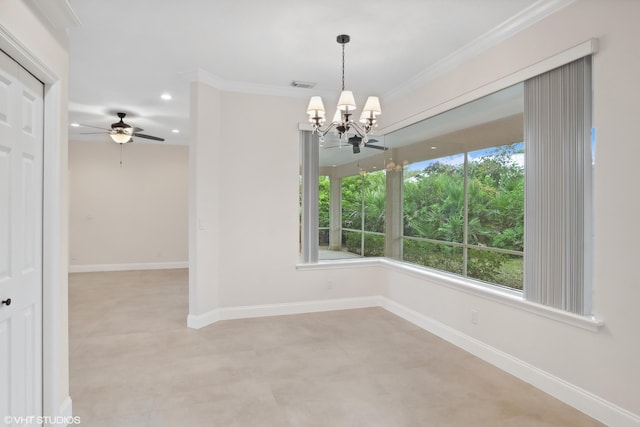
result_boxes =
[187,296,380,329]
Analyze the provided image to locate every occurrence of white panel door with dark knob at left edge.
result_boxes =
[0,51,44,426]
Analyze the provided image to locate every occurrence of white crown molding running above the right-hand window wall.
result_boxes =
[384,0,575,100]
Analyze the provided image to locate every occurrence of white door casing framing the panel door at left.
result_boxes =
[0,24,71,416]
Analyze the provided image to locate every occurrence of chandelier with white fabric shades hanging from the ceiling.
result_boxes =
[307,34,382,144]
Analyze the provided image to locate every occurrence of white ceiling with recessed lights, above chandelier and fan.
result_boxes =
[69,0,570,144]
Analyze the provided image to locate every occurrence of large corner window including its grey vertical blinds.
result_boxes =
[301,56,592,314]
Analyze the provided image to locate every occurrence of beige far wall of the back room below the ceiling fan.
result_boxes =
[69,140,189,271]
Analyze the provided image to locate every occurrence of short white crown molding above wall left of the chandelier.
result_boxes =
[182,68,318,98]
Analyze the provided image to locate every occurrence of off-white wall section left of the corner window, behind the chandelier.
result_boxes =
[190,88,381,315]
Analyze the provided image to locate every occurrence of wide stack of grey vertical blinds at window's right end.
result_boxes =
[524,56,591,315]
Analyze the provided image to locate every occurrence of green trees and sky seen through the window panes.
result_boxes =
[319,144,524,289]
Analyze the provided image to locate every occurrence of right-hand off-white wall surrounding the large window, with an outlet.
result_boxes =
[386,1,640,420]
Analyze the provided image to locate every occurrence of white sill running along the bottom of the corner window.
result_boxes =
[296,258,604,332]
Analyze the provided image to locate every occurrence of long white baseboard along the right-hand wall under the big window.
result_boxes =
[379,297,640,427]
